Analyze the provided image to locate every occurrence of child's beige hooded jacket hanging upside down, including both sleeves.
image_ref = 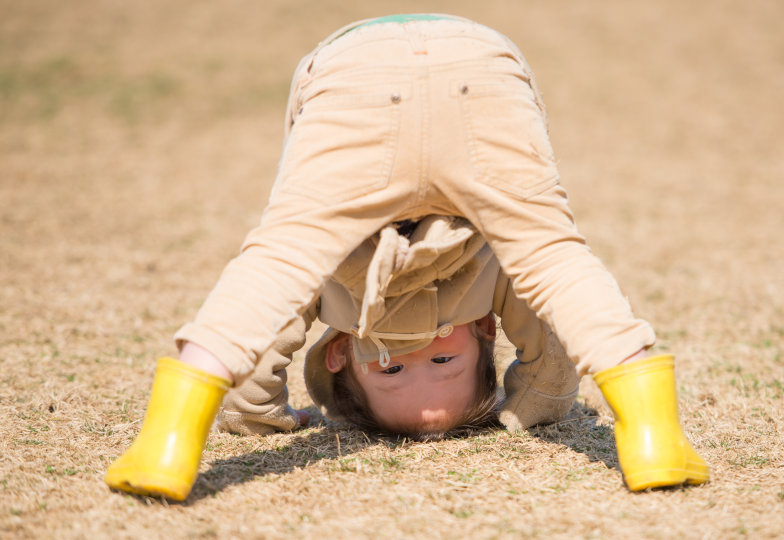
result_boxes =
[219,216,578,433]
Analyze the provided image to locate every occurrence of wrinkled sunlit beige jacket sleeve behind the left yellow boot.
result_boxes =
[216,302,318,435]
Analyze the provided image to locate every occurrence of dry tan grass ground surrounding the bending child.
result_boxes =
[0,0,784,539]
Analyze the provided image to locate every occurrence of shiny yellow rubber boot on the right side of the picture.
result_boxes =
[593,355,710,491]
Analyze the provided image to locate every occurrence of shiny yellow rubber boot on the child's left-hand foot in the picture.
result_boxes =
[104,358,231,501]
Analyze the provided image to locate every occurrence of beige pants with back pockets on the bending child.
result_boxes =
[176,16,654,379]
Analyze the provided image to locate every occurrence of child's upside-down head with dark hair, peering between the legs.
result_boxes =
[324,315,496,439]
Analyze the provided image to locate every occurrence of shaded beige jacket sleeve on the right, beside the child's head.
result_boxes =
[493,276,580,431]
